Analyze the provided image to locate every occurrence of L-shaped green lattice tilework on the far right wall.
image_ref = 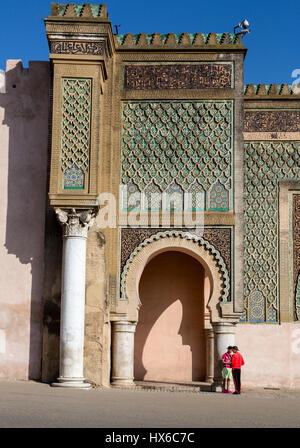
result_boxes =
[241,141,300,323]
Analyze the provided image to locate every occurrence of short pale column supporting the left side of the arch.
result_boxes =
[111,321,136,387]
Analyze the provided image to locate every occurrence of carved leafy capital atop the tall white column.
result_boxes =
[55,208,97,238]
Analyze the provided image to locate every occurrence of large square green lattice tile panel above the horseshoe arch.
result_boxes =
[121,100,233,210]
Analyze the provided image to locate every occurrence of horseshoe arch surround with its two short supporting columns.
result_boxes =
[111,229,240,387]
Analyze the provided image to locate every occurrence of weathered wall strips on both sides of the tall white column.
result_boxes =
[42,217,111,386]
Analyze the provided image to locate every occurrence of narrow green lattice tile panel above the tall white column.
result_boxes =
[61,78,92,189]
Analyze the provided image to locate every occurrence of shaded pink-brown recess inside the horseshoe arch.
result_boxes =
[134,250,206,381]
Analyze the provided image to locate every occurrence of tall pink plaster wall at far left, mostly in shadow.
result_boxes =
[0,61,49,379]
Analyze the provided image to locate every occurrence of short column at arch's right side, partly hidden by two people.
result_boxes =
[212,322,236,388]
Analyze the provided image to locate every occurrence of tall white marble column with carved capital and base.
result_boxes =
[52,209,93,389]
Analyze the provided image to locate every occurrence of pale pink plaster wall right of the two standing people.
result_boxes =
[236,323,300,388]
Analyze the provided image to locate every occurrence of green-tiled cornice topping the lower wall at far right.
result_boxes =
[244,84,300,99]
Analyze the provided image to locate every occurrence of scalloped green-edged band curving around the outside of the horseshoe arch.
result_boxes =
[121,230,230,303]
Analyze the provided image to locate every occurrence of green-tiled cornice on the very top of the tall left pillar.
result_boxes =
[51,3,108,20]
